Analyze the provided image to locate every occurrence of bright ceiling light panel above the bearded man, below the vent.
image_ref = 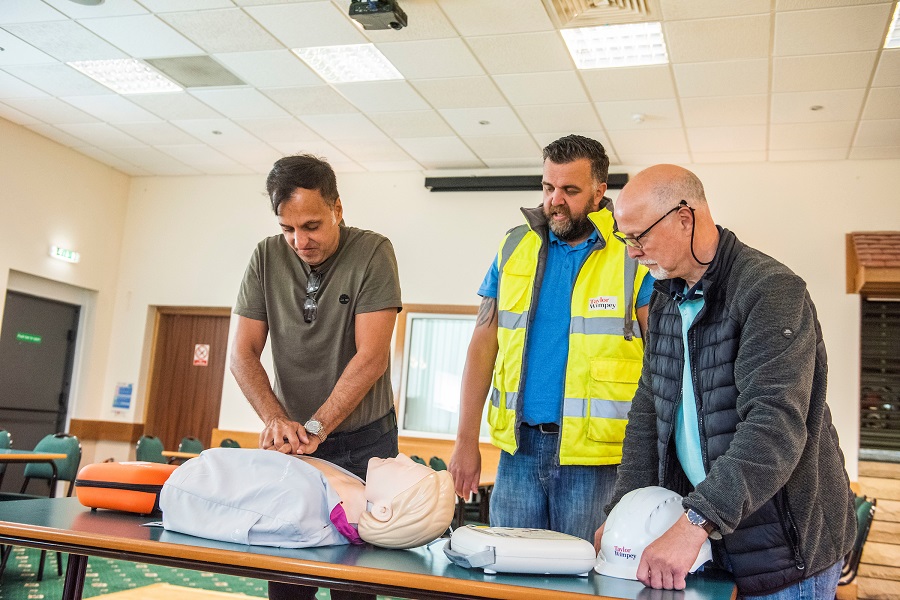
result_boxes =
[562,22,669,69]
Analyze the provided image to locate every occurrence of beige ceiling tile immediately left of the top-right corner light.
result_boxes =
[775,4,891,56]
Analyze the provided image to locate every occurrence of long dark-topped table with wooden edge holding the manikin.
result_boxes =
[0,498,736,600]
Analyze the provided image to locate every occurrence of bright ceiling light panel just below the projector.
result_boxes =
[293,44,403,83]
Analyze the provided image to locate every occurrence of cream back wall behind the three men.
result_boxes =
[105,160,900,478]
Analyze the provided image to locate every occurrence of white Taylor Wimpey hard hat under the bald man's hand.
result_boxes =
[594,486,712,579]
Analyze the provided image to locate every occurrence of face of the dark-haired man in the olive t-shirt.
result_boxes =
[278,188,343,267]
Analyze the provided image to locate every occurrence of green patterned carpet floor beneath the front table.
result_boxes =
[0,546,408,600]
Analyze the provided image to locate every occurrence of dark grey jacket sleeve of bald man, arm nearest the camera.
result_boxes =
[685,270,817,534]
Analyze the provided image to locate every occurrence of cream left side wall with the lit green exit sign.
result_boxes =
[0,119,130,432]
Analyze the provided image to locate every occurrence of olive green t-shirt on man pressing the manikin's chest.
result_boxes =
[234,226,403,432]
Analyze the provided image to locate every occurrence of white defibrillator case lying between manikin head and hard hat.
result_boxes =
[444,525,597,577]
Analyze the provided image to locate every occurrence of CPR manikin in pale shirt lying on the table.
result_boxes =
[160,448,455,548]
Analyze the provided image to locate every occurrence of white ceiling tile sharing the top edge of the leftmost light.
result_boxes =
[4,21,128,62]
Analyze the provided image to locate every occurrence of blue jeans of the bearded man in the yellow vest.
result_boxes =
[490,425,616,542]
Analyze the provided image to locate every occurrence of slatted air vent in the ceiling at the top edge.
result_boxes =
[544,0,662,28]
